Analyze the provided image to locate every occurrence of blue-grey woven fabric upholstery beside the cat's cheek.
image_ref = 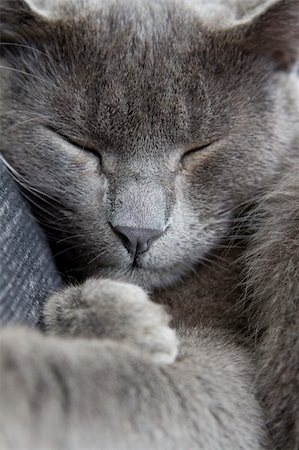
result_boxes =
[0,159,62,326]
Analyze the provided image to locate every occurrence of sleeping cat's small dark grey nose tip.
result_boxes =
[113,226,163,255]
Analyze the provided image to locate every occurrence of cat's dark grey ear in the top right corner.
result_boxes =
[234,0,299,70]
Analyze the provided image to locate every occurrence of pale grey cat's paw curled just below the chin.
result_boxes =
[44,279,178,364]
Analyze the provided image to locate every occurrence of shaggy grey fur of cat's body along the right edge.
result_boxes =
[246,152,299,449]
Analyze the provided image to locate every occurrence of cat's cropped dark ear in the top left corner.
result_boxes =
[0,0,46,43]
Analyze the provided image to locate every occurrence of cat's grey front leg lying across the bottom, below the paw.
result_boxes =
[0,327,266,450]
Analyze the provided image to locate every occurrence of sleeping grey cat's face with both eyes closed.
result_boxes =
[2,0,297,289]
